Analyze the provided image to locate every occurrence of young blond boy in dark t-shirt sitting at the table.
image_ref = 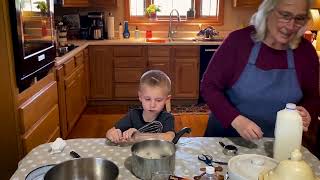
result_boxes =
[106,70,175,143]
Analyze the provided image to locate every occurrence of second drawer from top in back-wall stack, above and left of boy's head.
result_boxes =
[114,57,146,68]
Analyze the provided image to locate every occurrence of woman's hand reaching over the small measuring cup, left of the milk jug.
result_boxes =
[231,115,263,140]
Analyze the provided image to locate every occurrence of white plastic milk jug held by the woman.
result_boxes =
[273,103,303,161]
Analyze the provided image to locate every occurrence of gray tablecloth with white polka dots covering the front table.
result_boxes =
[11,137,320,180]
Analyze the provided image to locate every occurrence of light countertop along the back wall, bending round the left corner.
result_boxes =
[55,38,222,66]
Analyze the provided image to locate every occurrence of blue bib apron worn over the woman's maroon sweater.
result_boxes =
[204,42,302,137]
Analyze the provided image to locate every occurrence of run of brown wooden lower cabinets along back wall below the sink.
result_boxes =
[89,45,200,102]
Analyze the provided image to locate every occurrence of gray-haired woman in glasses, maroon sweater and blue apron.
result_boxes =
[201,0,319,140]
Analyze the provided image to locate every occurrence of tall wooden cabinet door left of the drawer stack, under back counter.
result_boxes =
[89,46,113,100]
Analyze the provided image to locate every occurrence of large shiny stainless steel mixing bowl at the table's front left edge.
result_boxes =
[44,158,119,180]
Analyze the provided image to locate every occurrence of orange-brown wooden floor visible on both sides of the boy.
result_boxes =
[68,105,208,139]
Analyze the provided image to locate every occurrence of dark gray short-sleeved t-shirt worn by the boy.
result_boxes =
[115,108,175,133]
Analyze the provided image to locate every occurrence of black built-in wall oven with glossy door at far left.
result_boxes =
[9,0,56,92]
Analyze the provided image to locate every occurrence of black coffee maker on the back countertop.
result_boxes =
[88,12,104,40]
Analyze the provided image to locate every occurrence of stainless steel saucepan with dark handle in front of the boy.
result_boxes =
[131,127,191,180]
